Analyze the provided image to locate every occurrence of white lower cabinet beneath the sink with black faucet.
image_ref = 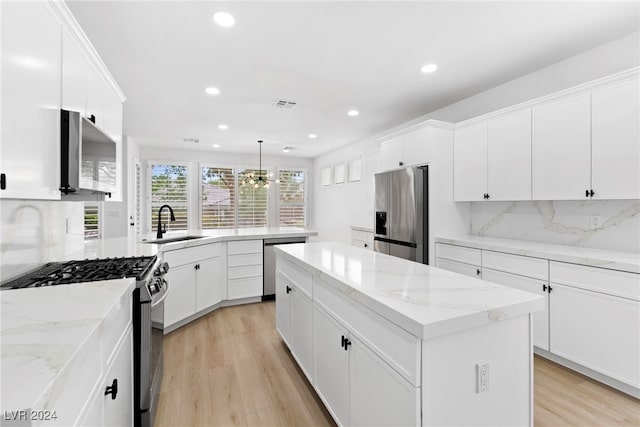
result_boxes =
[163,243,226,329]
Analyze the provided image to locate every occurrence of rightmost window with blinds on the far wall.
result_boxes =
[278,169,305,227]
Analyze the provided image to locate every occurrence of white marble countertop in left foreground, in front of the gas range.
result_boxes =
[0,278,135,415]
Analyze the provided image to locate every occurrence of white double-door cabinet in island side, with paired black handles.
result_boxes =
[313,305,420,426]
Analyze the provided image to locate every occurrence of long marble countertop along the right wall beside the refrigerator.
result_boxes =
[435,235,640,273]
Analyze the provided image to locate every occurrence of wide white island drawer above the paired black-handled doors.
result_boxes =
[313,279,420,386]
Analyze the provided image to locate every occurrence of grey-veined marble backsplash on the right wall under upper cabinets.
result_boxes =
[471,200,640,253]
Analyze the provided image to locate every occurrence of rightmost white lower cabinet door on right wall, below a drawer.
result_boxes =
[550,282,640,388]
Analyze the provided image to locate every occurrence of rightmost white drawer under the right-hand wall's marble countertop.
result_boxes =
[550,261,640,301]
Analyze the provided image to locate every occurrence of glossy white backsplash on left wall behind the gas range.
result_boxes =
[0,199,84,281]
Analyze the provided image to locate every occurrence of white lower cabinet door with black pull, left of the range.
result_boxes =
[77,326,133,426]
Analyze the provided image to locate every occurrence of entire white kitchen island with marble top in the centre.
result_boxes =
[276,242,544,425]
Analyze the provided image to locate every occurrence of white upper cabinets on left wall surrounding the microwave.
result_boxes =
[0,1,124,200]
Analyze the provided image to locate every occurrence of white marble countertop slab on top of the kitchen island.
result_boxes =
[276,242,544,339]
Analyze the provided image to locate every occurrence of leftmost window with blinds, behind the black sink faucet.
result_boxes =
[149,163,189,230]
